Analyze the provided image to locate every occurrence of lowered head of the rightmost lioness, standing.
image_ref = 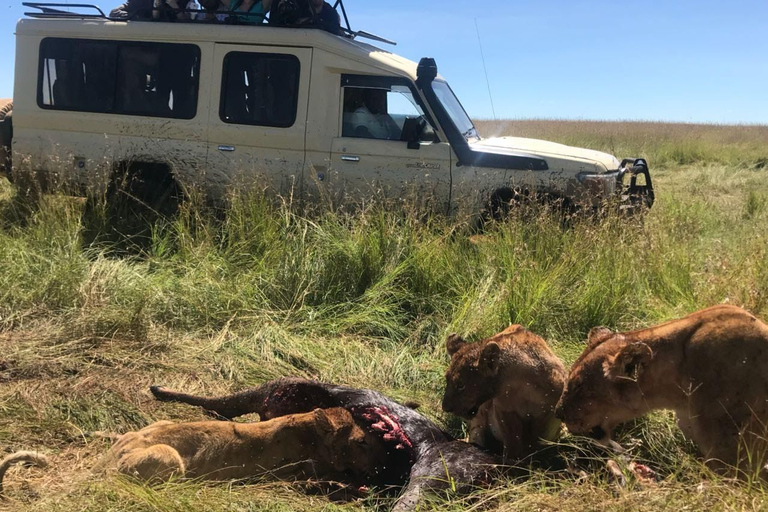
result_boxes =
[556,327,653,443]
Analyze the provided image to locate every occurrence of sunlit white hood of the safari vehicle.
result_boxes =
[471,137,620,170]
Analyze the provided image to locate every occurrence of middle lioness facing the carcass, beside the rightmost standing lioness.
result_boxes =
[443,325,566,459]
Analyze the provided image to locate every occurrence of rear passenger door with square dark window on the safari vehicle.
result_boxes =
[207,44,312,196]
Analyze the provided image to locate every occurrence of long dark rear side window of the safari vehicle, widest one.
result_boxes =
[37,38,200,119]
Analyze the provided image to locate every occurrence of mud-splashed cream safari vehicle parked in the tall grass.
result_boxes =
[2,1,654,224]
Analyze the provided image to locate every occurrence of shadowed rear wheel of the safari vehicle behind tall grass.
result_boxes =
[82,163,184,253]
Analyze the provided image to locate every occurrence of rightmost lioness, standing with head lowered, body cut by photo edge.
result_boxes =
[557,305,768,476]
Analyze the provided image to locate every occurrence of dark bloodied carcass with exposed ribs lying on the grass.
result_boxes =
[151,378,501,512]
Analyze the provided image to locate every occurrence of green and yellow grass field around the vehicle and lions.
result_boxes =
[0,121,768,512]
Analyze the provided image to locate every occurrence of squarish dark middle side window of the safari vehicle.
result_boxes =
[219,52,301,128]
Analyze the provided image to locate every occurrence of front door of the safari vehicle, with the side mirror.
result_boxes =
[326,75,452,212]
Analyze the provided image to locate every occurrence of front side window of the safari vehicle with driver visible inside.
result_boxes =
[341,85,434,141]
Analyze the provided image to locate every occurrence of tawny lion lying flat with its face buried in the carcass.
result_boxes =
[110,408,386,483]
